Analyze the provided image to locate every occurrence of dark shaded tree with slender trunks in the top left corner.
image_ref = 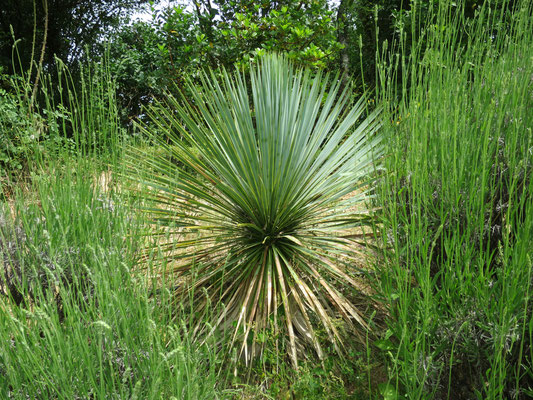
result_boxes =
[0,0,147,73]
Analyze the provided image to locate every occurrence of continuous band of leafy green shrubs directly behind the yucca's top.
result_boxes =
[109,0,341,121]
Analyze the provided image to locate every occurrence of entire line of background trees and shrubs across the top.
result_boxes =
[0,0,514,130]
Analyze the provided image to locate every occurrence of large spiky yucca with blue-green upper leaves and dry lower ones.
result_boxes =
[127,55,380,366]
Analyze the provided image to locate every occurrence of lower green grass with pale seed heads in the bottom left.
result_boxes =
[0,167,223,399]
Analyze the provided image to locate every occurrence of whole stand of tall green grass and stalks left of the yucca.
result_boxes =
[0,55,227,399]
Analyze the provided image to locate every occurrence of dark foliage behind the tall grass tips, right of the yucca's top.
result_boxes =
[336,0,519,88]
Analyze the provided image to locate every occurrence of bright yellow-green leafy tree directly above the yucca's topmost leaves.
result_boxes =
[191,0,341,68]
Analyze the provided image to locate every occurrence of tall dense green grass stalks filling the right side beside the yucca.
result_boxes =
[378,1,533,399]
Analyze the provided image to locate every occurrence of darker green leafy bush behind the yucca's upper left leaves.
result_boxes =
[104,7,207,125]
